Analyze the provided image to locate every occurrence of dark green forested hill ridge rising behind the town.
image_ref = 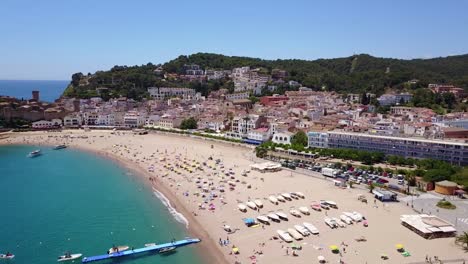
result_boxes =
[64,53,468,99]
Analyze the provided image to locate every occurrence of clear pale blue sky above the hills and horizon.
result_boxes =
[0,0,468,79]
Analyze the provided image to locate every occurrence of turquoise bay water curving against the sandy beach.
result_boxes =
[0,146,202,264]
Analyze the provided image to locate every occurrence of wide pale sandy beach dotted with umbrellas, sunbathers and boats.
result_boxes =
[0,130,467,264]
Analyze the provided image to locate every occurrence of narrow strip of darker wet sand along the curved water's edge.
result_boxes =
[0,137,229,264]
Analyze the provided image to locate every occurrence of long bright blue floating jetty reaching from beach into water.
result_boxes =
[81,238,201,263]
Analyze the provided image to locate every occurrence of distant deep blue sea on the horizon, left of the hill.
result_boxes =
[0,80,70,102]
